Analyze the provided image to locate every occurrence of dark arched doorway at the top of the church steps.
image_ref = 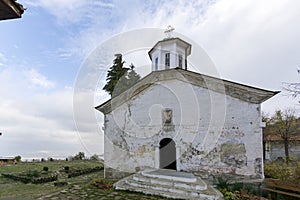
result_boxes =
[159,138,176,170]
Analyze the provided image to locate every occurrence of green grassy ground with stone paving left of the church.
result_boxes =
[0,161,166,200]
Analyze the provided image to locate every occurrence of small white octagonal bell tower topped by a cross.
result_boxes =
[148,26,192,71]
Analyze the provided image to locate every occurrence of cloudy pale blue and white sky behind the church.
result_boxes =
[0,0,300,158]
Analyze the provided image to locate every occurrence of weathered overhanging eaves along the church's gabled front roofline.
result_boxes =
[95,68,279,114]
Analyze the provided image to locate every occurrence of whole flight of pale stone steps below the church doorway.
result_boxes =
[114,171,223,200]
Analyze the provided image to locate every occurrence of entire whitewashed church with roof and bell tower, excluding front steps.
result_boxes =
[96,38,277,178]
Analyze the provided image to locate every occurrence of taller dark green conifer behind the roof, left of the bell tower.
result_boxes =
[103,54,129,96]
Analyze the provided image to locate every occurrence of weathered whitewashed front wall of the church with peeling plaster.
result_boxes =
[104,80,263,178]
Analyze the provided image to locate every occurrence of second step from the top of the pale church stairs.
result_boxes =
[132,173,207,190]
